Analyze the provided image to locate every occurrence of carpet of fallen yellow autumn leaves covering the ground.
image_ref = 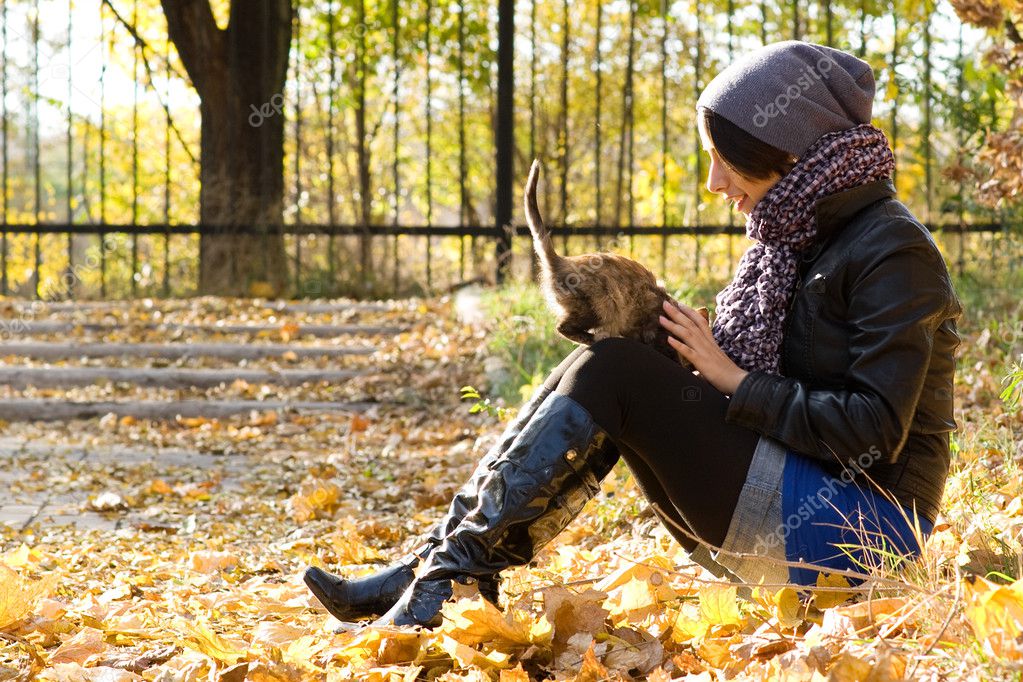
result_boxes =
[0,290,1023,682]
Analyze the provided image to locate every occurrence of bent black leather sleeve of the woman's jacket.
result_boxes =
[726,228,955,465]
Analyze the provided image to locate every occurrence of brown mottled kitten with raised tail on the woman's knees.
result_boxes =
[525,160,679,362]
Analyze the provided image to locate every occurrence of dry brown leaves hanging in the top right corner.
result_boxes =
[951,0,1023,206]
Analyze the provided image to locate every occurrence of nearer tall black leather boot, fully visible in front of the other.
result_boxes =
[377,394,618,626]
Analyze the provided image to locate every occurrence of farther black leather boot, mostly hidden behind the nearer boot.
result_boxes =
[303,385,585,621]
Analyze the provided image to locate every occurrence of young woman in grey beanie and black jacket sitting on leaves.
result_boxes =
[306,41,960,625]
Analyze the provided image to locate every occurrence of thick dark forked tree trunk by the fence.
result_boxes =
[161,0,292,295]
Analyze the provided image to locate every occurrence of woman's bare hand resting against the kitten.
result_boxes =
[660,301,747,396]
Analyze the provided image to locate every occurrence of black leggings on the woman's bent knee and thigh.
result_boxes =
[544,338,759,551]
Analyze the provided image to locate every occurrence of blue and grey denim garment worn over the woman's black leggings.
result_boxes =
[711,438,932,586]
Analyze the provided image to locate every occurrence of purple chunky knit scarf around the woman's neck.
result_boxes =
[713,124,895,374]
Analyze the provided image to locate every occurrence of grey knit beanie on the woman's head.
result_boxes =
[697,40,874,157]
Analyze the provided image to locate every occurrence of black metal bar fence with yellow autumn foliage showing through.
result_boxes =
[0,0,1015,299]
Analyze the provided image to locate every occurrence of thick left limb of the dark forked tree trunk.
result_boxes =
[160,0,226,98]
